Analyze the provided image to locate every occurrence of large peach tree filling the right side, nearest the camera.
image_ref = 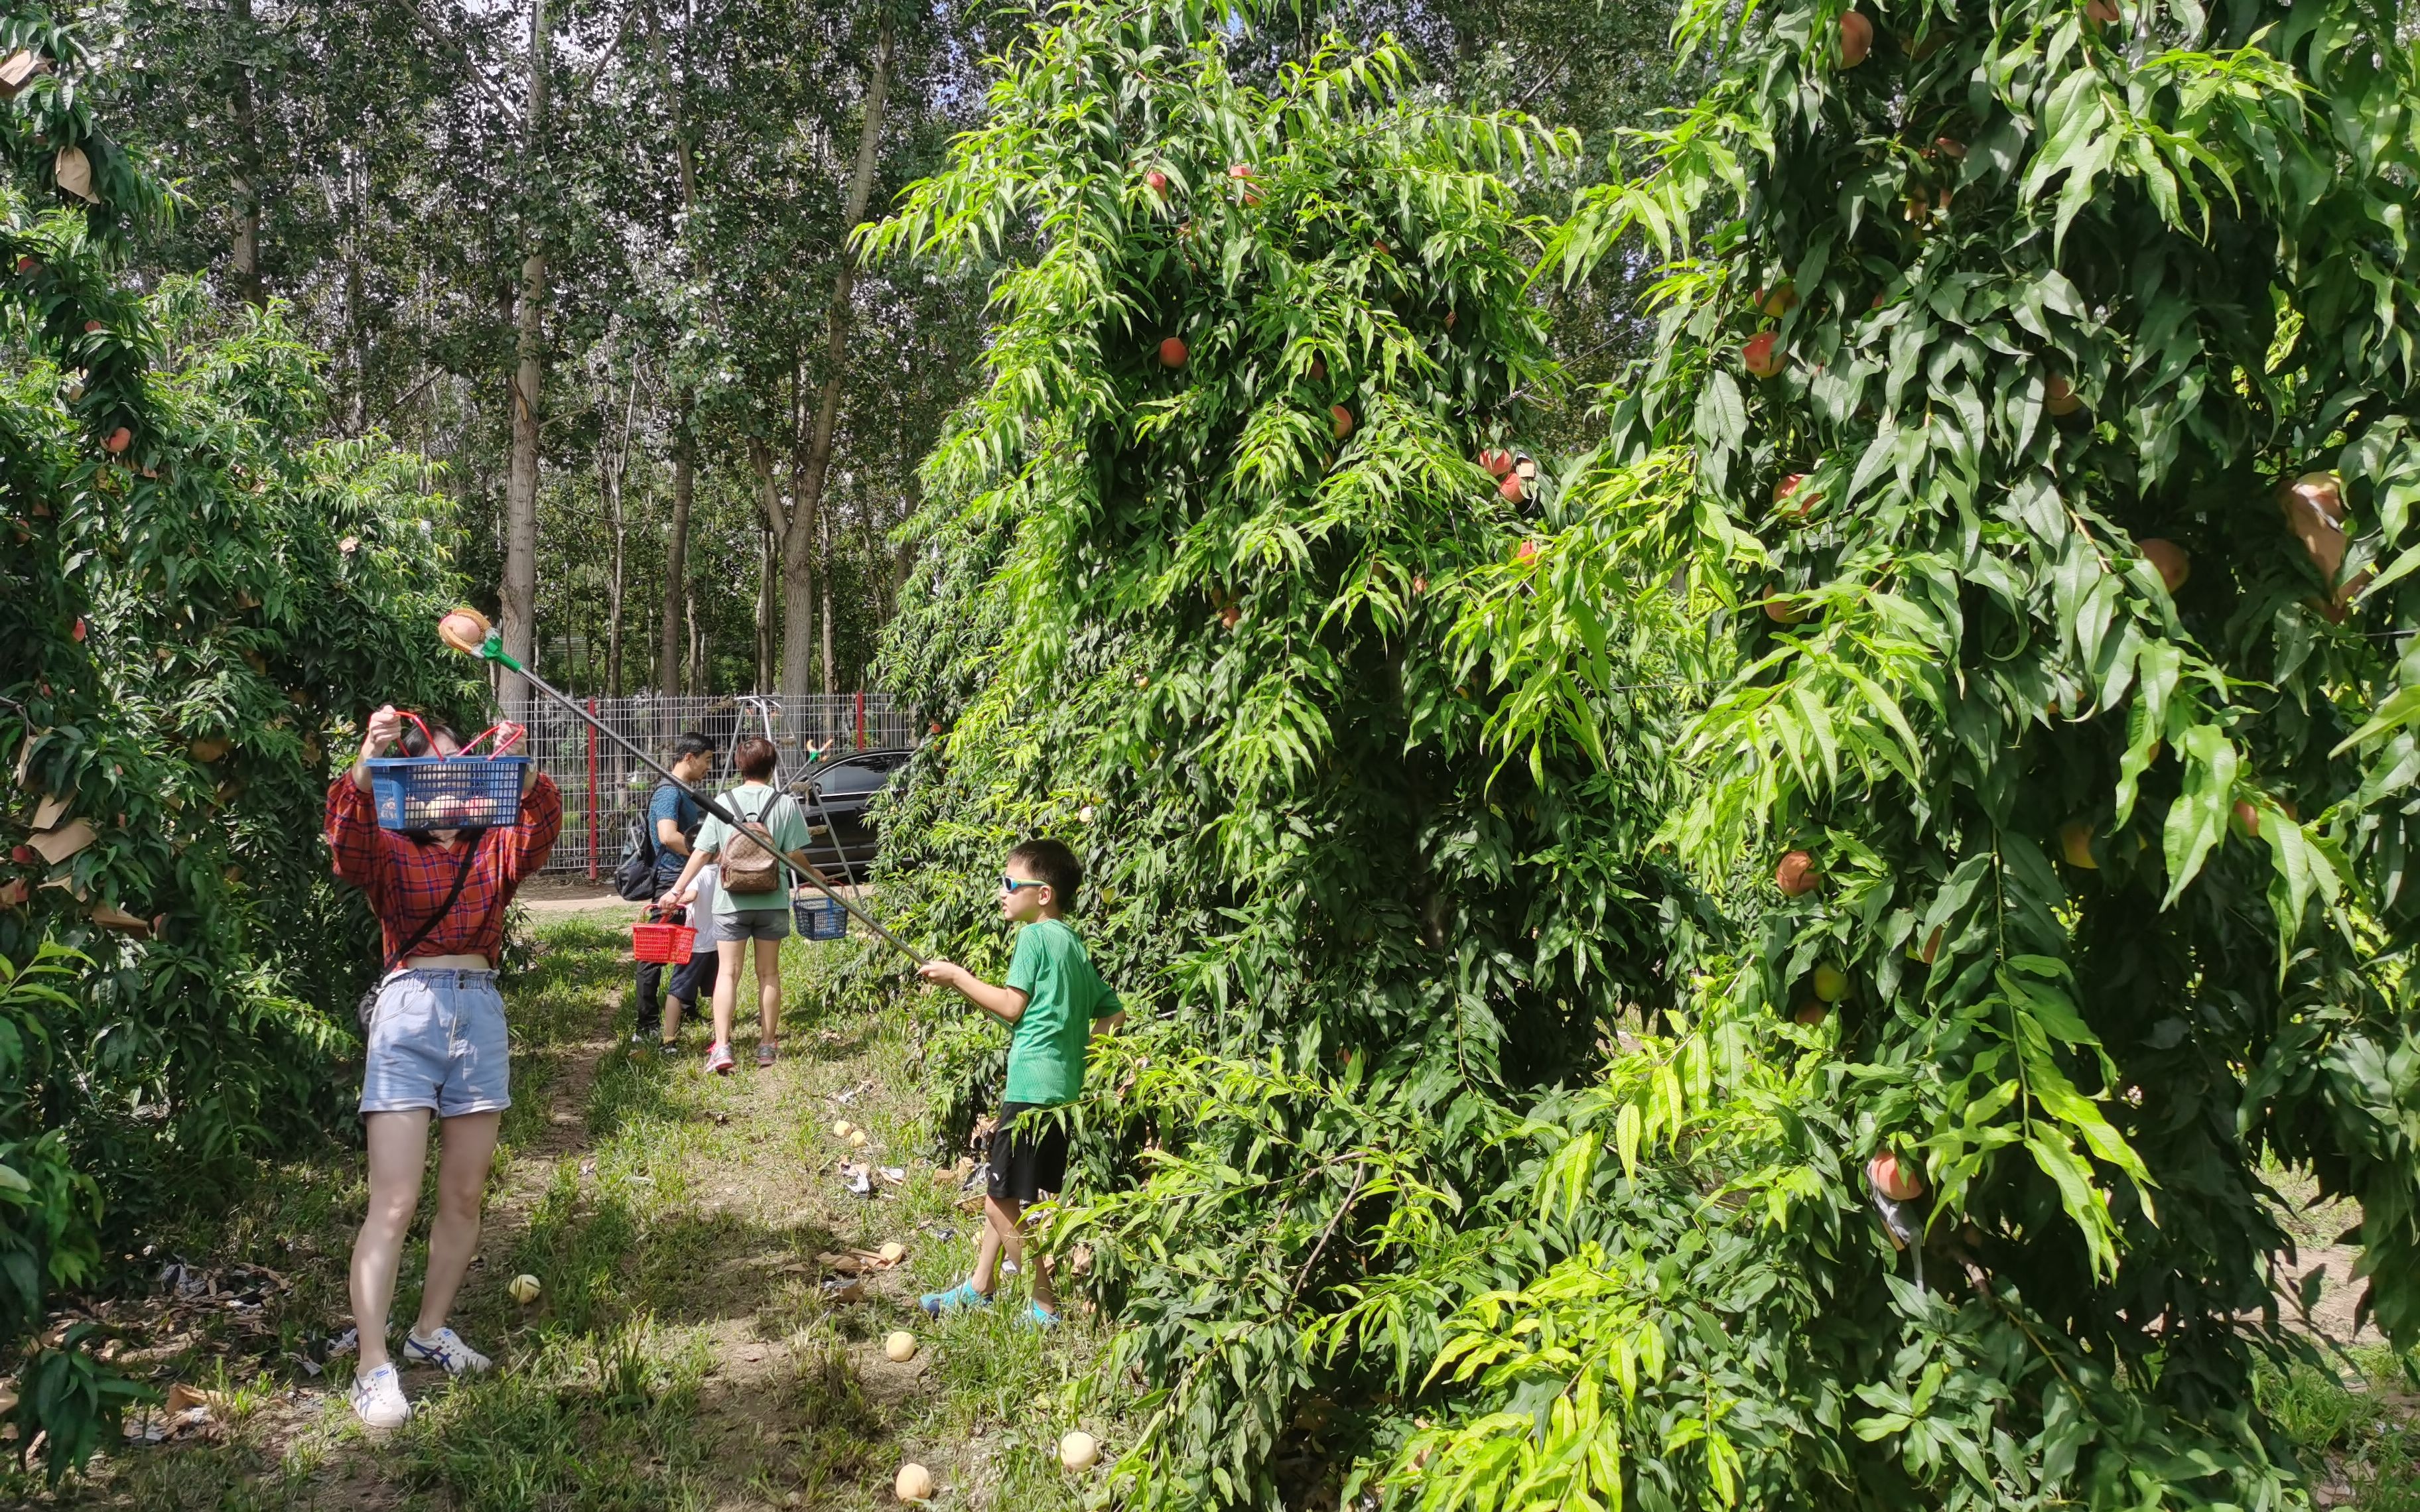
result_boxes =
[1372,0,2420,1507]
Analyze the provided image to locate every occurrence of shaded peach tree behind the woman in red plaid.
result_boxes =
[0,17,477,1474]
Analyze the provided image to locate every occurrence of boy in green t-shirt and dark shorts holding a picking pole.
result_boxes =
[922,840,1125,1328]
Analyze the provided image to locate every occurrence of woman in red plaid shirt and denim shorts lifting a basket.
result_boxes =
[326,704,564,1427]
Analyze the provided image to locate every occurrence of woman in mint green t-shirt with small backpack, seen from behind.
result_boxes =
[663,735,808,1076]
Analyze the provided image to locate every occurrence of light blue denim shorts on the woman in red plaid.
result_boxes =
[361,970,513,1117]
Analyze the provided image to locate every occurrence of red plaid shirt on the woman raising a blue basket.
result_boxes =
[326,772,564,966]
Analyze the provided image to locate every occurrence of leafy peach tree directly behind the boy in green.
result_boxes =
[871,3,1728,1507]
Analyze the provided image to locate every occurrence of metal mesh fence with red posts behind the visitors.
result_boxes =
[527,692,922,878]
